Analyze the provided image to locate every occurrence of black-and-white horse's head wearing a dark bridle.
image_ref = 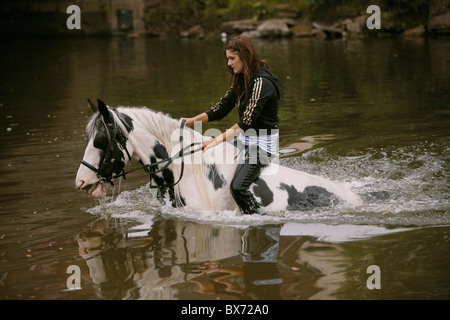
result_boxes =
[75,99,133,198]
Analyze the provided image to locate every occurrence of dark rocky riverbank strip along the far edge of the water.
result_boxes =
[0,0,450,39]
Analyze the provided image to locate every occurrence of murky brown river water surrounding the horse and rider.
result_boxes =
[0,38,450,300]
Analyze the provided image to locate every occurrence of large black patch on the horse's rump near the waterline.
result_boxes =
[280,183,336,211]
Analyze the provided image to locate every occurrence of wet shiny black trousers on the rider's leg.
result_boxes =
[230,149,268,214]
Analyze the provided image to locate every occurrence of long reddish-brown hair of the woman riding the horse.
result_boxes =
[225,36,267,97]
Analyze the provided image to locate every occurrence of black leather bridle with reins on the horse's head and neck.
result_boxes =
[81,119,202,188]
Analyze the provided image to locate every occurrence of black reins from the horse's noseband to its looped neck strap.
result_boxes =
[81,119,201,189]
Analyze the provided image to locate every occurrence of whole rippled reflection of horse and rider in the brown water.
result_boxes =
[77,219,370,300]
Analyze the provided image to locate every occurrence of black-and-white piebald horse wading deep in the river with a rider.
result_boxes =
[75,99,362,213]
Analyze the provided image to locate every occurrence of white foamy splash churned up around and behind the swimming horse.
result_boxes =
[88,140,450,228]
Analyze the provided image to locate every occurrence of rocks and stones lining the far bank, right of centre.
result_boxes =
[179,1,450,39]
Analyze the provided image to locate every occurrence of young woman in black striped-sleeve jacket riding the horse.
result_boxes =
[183,36,280,214]
